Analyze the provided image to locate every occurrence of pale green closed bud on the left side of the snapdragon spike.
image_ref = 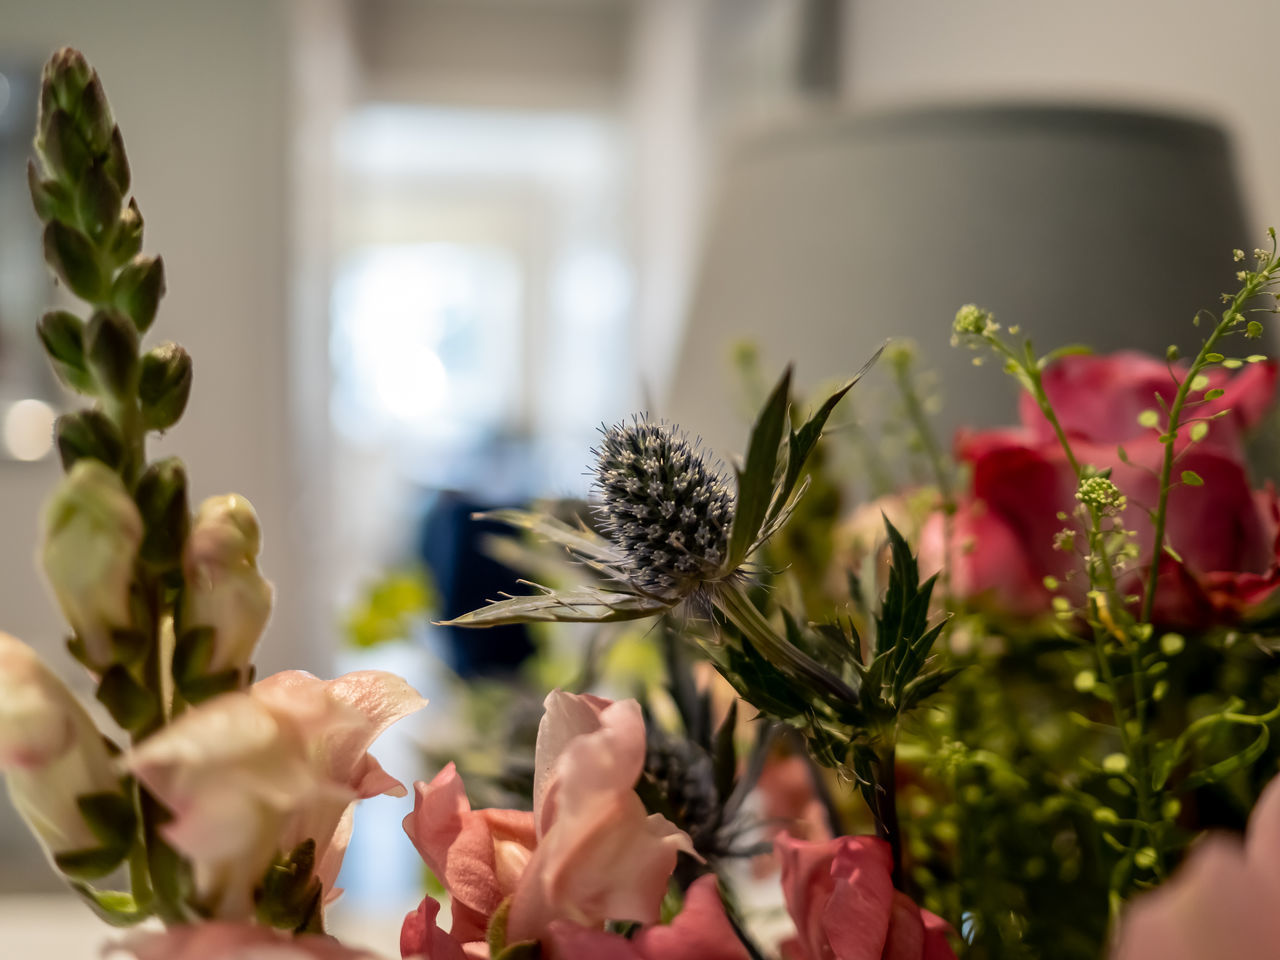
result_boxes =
[41,458,142,671]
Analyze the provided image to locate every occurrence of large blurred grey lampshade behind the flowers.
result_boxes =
[663,106,1261,452]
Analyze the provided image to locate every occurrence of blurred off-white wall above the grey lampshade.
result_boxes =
[845,0,1280,228]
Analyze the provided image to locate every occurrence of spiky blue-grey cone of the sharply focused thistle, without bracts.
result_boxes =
[595,417,733,596]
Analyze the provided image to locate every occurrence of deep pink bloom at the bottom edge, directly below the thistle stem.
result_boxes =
[774,837,955,960]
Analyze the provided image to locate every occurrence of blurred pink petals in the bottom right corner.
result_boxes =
[1111,777,1280,960]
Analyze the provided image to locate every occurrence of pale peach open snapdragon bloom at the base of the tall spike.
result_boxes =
[125,671,426,920]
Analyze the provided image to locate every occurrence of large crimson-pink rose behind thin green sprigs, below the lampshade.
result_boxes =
[920,352,1280,628]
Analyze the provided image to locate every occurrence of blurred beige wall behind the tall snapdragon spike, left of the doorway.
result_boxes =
[0,0,304,886]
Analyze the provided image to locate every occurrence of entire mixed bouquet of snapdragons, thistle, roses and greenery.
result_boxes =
[0,50,1280,960]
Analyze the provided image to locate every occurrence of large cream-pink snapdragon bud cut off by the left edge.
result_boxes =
[0,632,120,855]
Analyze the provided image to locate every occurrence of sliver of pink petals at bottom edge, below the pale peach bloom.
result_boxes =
[106,923,391,960]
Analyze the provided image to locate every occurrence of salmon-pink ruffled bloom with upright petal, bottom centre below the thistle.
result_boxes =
[404,691,692,945]
